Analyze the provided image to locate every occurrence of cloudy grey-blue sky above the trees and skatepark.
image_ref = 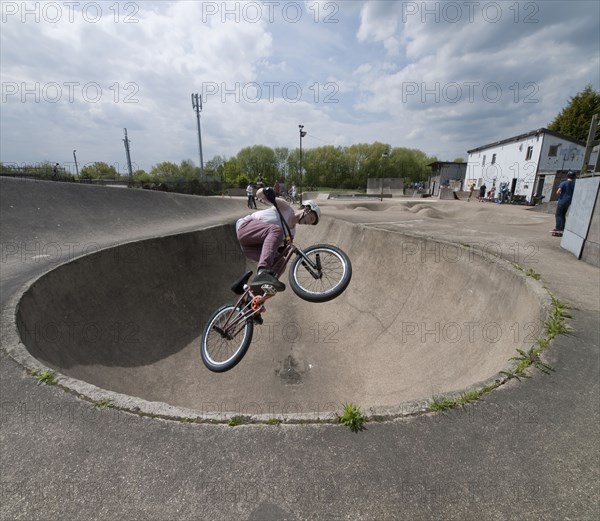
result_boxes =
[0,0,600,173]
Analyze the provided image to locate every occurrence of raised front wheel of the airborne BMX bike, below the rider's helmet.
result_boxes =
[289,244,352,302]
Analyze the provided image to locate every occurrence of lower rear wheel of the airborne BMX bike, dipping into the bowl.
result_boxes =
[200,304,254,373]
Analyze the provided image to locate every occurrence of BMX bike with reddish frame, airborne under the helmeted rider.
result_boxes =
[200,219,352,373]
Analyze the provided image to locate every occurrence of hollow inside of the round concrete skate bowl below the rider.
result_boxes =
[1,178,546,420]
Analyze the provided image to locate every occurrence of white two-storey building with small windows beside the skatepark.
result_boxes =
[464,128,585,202]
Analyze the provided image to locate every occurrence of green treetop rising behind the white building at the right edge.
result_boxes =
[548,85,600,142]
